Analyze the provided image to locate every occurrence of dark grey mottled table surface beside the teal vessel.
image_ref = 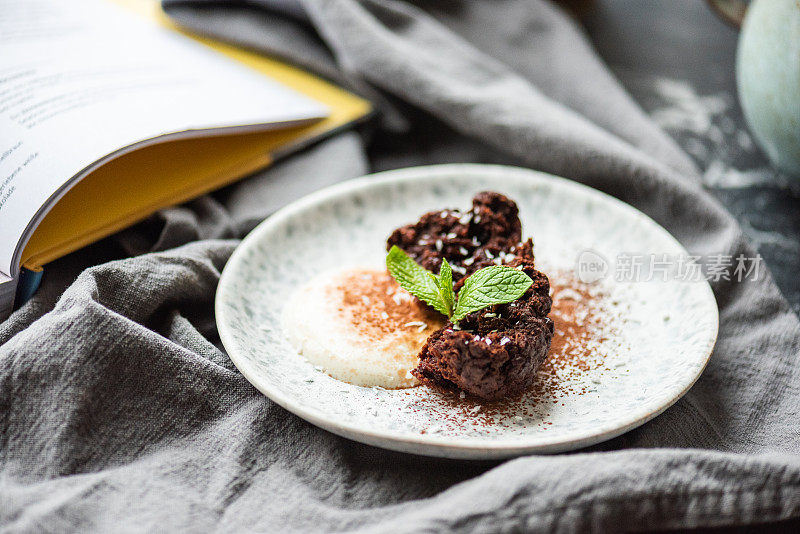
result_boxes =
[583,0,800,314]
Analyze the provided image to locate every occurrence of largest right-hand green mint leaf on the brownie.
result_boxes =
[452,265,533,321]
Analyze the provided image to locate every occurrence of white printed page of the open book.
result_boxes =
[0,0,328,276]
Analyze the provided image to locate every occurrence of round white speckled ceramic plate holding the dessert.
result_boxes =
[216,164,718,459]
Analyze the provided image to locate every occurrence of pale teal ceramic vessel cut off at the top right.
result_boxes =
[736,0,800,178]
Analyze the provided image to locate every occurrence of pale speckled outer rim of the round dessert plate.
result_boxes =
[215,163,719,460]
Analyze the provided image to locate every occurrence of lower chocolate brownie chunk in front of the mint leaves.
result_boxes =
[412,240,553,400]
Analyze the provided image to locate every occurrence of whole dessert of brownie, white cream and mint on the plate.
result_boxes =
[284,192,553,400]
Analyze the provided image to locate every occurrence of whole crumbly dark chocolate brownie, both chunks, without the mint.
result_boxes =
[388,192,553,400]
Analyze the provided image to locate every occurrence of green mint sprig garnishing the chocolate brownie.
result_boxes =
[386,246,533,322]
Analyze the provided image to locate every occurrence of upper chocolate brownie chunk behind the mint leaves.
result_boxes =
[386,191,522,290]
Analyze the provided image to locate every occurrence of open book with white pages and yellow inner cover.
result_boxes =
[0,0,370,320]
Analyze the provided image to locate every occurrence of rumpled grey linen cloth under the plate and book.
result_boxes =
[0,0,800,532]
